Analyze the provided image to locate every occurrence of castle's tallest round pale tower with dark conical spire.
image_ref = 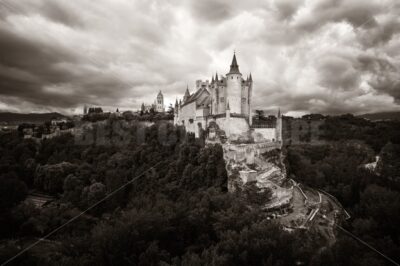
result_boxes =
[226,53,242,114]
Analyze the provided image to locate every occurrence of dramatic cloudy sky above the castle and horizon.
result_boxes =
[0,0,400,115]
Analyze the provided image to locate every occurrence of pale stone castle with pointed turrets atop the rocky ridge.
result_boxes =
[174,53,282,142]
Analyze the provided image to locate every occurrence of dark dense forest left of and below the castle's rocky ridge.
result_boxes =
[0,121,313,265]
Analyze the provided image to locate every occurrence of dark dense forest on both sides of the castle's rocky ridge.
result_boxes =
[0,117,400,265]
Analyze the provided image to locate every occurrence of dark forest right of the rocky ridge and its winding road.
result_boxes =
[286,115,400,265]
